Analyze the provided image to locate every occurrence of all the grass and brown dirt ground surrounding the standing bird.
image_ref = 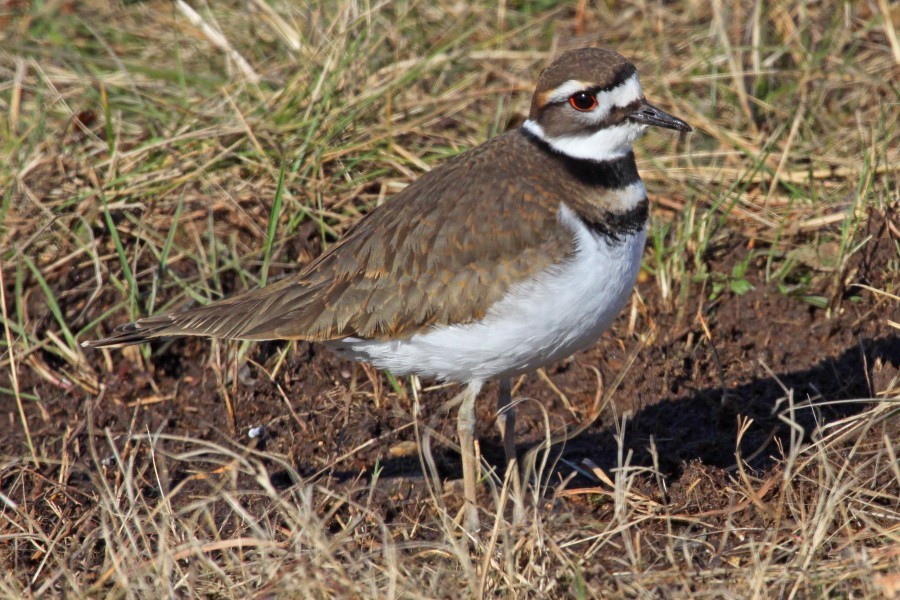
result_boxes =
[0,0,900,598]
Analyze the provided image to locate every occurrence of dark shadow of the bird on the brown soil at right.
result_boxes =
[562,336,900,477]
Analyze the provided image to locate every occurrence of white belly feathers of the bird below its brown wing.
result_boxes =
[328,206,647,382]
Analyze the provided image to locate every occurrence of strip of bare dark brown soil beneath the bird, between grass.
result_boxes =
[0,207,900,580]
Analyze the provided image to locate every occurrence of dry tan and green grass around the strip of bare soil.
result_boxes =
[0,0,900,598]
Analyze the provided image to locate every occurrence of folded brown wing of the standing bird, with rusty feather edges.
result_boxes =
[88,132,574,346]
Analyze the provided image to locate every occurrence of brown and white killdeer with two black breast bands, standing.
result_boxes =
[84,48,691,530]
